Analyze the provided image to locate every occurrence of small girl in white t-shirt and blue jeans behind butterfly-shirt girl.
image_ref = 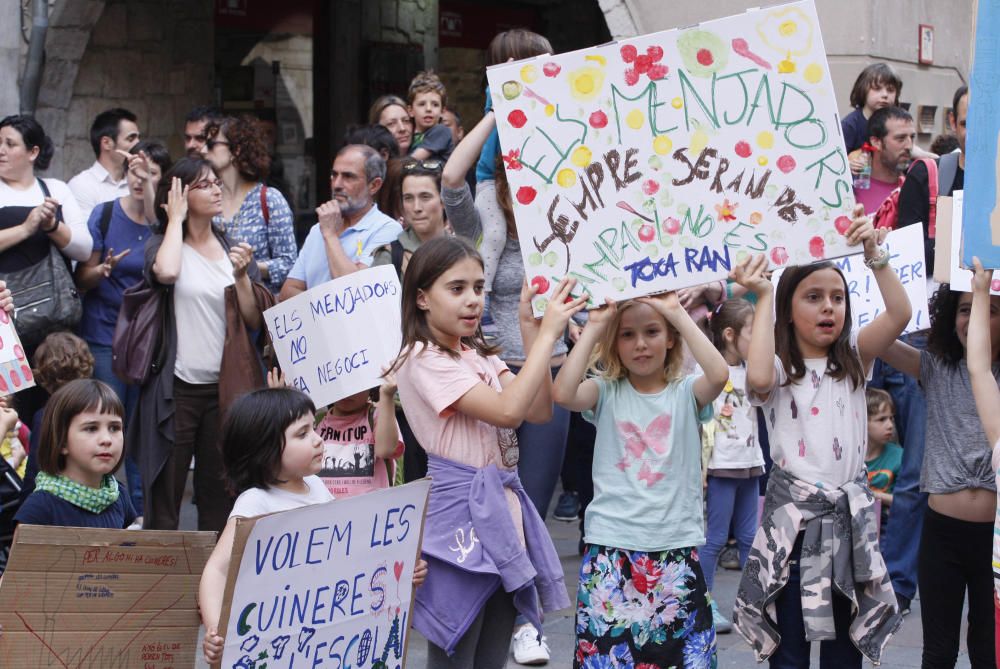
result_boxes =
[700,298,764,633]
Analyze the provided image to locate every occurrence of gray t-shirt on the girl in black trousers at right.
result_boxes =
[916,351,1000,494]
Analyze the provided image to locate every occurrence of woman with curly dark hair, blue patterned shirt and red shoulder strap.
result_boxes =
[204,116,298,294]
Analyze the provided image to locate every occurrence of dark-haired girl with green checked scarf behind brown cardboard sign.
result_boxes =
[14,379,136,530]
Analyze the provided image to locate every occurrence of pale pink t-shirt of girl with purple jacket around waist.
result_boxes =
[396,344,522,530]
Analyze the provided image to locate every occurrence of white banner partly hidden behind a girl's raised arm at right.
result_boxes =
[771,225,931,333]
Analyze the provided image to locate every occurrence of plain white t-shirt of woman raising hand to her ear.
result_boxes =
[174,243,234,383]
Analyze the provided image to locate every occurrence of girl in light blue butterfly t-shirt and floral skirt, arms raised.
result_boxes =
[553,293,729,667]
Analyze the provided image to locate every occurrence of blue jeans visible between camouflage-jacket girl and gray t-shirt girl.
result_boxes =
[868,333,927,599]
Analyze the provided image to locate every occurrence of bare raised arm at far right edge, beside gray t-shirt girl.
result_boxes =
[966,258,1000,445]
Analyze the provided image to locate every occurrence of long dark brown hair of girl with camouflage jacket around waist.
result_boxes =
[774,262,865,389]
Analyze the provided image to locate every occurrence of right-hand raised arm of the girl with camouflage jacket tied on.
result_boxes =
[847,204,912,369]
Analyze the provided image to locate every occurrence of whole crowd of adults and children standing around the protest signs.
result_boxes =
[0,29,1000,669]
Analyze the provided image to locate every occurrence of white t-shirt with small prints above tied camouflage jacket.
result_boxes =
[747,331,871,489]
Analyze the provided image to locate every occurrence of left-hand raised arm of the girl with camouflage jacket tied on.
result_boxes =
[732,254,775,398]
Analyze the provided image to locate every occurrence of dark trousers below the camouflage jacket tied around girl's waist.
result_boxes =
[769,532,861,669]
